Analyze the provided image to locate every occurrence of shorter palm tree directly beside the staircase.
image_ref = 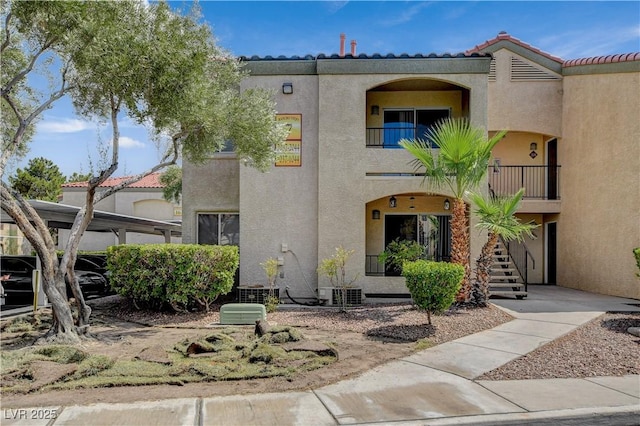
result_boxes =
[470,188,538,306]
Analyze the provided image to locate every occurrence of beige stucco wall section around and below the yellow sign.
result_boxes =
[240,75,318,298]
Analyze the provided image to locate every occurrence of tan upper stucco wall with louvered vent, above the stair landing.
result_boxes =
[487,49,562,135]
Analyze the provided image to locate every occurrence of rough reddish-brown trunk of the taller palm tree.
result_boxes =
[451,198,471,303]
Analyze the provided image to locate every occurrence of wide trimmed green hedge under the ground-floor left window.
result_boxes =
[107,244,239,310]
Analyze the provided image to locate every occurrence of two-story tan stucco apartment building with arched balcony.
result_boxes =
[182,33,640,299]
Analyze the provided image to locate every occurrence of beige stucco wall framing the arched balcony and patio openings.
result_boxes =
[318,74,487,293]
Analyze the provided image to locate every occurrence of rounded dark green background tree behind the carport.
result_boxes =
[9,157,65,202]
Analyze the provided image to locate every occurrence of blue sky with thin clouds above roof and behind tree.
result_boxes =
[11,0,640,176]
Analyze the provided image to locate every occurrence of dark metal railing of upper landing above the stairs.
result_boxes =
[487,165,560,200]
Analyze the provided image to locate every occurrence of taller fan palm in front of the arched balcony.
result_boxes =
[399,118,506,302]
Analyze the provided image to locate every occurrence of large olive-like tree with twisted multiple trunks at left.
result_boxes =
[0,0,286,343]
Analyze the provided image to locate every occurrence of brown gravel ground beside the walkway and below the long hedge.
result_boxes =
[92,296,640,380]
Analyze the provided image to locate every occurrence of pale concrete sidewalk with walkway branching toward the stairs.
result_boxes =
[1,286,640,426]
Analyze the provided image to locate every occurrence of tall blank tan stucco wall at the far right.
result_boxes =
[558,72,640,299]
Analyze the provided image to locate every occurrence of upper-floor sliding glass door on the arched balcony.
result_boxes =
[367,108,451,148]
